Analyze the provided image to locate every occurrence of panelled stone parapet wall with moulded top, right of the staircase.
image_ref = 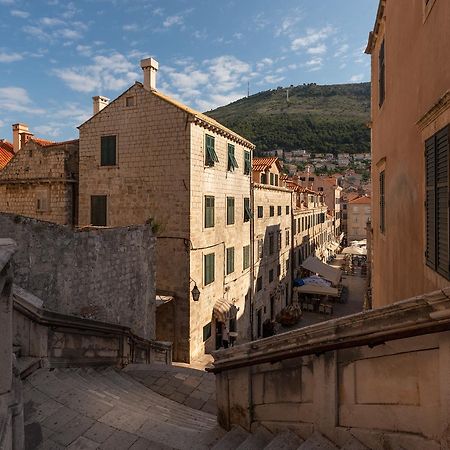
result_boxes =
[214,289,450,450]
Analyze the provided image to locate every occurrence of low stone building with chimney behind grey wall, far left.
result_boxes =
[0,124,78,225]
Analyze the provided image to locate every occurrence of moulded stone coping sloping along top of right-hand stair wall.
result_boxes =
[209,288,450,372]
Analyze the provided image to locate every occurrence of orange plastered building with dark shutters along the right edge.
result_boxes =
[366,0,450,307]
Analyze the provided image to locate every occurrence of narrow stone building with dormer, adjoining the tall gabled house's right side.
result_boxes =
[252,157,293,338]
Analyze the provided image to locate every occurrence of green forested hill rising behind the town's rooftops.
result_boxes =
[205,83,370,154]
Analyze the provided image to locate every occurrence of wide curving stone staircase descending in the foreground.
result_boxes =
[24,368,365,450]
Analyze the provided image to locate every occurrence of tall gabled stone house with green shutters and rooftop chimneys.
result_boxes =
[79,58,254,361]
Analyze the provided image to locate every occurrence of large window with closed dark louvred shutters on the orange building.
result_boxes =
[425,126,450,279]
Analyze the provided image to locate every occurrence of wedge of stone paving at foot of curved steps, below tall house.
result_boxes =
[125,358,217,414]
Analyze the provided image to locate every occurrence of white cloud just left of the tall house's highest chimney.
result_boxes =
[54,53,138,92]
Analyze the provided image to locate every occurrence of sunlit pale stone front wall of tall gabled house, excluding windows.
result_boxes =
[189,124,251,357]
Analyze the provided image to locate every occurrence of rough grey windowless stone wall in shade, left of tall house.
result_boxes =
[0,214,156,339]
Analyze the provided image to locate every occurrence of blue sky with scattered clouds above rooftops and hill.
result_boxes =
[0,0,378,140]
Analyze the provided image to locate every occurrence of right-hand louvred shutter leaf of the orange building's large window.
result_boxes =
[435,127,450,278]
